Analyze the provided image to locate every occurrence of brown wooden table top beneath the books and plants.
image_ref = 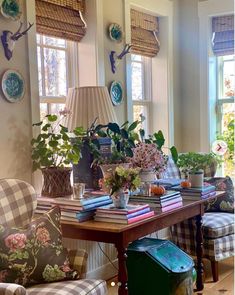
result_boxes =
[61,191,224,233]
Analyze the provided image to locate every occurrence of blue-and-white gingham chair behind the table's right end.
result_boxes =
[166,159,234,282]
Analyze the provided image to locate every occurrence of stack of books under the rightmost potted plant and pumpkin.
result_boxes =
[172,184,216,200]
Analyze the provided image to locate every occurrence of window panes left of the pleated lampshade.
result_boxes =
[37,34,69,118]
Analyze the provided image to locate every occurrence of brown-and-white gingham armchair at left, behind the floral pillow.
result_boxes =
[0,179,107,295]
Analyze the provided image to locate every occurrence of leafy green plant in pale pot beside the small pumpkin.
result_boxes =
[177,152,220,187]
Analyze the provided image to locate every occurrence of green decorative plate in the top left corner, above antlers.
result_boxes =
[0,0,22,20]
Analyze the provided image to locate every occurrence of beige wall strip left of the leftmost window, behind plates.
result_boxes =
[0,1,38,182]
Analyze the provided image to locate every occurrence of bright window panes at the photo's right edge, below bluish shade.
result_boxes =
[216,55,235,177]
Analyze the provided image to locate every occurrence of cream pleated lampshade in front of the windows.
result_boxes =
[64,86,117,131]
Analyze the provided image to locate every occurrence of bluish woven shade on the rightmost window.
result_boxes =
[212,15,234,56]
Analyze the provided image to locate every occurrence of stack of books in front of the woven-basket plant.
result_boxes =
[36,194,112,222]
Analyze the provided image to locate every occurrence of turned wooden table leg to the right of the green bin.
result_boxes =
[196,215,204,291]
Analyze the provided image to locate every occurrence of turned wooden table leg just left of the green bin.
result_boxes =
[116,245,128,295]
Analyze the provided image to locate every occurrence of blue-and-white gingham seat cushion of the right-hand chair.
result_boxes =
[203,212,234,239]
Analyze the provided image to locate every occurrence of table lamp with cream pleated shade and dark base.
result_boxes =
[64,86,117,189]
